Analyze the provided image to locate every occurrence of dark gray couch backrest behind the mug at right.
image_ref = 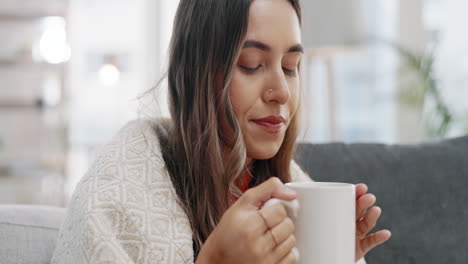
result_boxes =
[296,137,468,264]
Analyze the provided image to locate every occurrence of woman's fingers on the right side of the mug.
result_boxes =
[356,183,392,261]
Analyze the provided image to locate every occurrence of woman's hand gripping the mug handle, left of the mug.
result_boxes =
[197,177,296,264]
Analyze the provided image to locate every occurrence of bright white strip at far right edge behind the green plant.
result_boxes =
[425,0,468,136]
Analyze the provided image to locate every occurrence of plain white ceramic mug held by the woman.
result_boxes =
[263,182,356,264]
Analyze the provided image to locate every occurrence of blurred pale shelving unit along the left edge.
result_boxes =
[0,0,69,206]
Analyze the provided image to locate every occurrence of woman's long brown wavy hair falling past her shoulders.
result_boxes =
[152,0,301,256]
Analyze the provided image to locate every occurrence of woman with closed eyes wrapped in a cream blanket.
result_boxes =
[53,0,390,263]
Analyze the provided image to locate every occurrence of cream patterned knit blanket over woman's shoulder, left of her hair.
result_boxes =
[52,120,193,263]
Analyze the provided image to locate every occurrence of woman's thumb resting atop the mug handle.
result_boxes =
[241,177,297,209]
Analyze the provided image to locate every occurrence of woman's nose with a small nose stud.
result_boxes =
[263,68,291,104]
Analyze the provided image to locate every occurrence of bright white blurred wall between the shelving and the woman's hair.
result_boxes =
[66,0,178,199]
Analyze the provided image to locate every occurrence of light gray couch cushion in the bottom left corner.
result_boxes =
[0,205,65,264]
